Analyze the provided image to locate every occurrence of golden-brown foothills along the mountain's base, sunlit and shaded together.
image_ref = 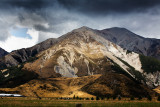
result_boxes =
[0,73,156,97]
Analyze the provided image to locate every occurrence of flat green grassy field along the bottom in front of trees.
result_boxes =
[0,98,160,107]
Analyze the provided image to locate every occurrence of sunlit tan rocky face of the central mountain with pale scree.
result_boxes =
[24,27,142,77]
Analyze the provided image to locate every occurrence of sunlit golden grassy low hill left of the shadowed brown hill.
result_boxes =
[0,75,100,97]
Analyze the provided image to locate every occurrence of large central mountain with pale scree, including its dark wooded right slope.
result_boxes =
[23,27,160,87]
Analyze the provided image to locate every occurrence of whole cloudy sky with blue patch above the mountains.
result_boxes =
[0,0,160,52]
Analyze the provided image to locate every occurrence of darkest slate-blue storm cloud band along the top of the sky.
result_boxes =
[0,0,160,14]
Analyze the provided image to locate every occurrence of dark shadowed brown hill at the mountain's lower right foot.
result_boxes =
[82,73,155,97]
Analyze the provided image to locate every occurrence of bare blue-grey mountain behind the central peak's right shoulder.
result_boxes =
[99,27,160,60]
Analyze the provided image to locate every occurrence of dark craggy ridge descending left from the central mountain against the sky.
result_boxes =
[0,38,57,68]
